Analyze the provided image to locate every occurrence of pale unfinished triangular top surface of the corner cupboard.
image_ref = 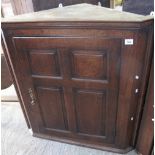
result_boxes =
[2,3,153,23]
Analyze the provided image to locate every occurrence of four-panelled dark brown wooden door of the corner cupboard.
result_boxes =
[13,37,121,143]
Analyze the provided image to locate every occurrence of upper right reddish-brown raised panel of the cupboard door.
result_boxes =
[71,50,108,80]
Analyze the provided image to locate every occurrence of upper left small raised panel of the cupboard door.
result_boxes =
[29,50,60,76]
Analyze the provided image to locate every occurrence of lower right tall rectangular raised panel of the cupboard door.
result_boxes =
[74,89,106,137]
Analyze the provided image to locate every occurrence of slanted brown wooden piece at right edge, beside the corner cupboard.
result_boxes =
[136,57,154,155]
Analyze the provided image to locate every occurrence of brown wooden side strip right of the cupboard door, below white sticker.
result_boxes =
[115,30,150,149]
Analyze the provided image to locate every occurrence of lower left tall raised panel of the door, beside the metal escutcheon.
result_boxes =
[36,87,67,130]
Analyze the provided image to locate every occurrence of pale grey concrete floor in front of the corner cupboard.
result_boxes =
[1,102,136,155]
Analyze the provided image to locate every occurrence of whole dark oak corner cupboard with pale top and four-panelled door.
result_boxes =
[2,4,153,153]
